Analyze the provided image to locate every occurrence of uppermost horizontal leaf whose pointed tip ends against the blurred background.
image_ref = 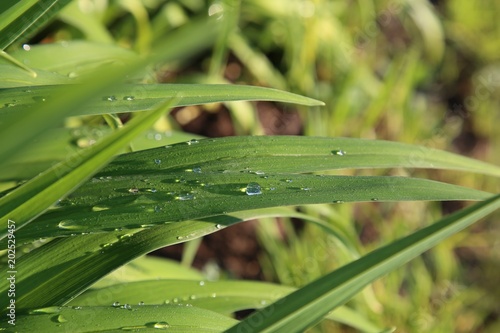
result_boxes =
[0,84,324,117]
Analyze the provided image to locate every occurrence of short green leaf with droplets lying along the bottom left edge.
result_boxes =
[1,304,237,333]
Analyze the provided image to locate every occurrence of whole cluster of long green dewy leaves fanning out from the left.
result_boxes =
[0,0,500,332]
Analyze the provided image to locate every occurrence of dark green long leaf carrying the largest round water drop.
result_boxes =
[11,173,491,243]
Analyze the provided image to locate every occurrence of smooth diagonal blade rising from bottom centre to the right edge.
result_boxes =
[226,195,500,333]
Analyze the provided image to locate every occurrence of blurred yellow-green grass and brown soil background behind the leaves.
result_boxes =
[11,0,500,332]
